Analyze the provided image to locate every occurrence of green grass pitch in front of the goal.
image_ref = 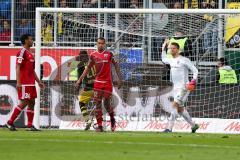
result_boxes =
[0,129,240,160]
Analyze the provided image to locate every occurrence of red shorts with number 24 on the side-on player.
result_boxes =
[18,86,37,100]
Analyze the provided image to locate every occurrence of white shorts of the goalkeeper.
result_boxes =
[173,88,190,106]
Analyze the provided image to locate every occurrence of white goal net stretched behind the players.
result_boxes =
[36,8,240,131]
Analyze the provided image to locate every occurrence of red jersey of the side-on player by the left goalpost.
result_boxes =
[16,48,35,86]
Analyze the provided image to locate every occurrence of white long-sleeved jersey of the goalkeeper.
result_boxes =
[162,51,198,89]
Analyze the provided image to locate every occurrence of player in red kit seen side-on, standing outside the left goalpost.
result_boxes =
[6,34,45,131]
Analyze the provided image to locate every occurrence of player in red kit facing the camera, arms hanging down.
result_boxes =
[76,37,122,132]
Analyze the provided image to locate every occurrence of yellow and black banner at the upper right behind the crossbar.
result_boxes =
[225,2,240,47]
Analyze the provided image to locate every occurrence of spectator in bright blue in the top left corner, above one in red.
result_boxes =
[0,0,11,20]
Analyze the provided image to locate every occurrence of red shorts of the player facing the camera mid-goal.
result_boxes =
[93,82,112,101]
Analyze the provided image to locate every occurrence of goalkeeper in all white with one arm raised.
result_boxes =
[162,39,199,133]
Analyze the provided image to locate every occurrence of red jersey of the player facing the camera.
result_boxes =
[90,51,113,83]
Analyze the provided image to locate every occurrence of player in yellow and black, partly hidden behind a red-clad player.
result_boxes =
[72,50,96,130]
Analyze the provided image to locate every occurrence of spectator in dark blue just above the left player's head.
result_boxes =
[16,17,34,40]
